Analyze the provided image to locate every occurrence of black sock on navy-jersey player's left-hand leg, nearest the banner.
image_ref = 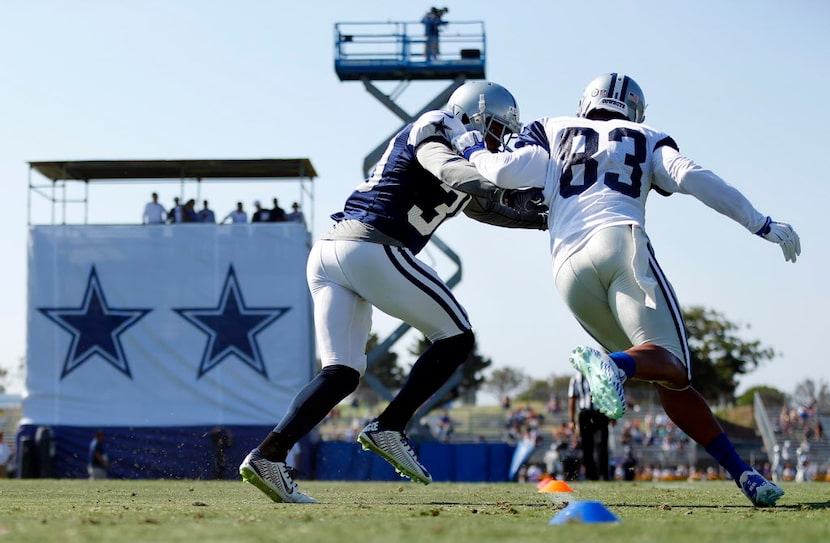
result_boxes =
[258,365,360,462]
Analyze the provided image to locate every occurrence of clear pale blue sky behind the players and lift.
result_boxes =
[0,0,830,400]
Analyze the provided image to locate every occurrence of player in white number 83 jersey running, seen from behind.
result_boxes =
[453,73,801,506]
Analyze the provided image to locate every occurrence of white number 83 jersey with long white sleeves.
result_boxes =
[470,117,766,273]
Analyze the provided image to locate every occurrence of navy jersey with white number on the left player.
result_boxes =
[331,111,470,254]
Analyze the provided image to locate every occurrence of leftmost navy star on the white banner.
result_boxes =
[38,266,151,380]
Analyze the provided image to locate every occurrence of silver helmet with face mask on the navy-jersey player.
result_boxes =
[447,81,522,149]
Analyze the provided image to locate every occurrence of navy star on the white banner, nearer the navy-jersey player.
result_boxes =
[173,266,291,379]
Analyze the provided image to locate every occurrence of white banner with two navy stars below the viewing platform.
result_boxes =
[23,223,315,426]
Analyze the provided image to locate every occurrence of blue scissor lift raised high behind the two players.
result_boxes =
[334,21,487,424]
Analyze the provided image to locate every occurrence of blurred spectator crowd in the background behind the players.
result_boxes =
[288,396,830,482]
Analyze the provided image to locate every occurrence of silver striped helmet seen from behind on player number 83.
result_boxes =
[576,73,646,123]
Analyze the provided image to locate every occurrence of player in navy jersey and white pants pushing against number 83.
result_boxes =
[240,81,547,503]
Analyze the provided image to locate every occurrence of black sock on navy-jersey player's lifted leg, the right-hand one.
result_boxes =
[378,330,475,432]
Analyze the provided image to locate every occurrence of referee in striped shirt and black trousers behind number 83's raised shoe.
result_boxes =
[568,372,616,481]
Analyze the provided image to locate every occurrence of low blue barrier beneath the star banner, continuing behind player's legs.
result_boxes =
[16,425,515,482]
